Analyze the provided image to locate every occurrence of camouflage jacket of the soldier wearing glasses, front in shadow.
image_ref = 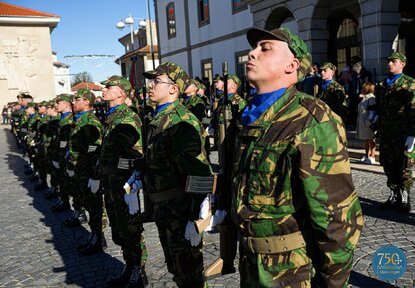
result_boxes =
[145,100,212,220]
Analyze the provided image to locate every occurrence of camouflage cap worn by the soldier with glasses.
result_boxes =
[143,62,189,94]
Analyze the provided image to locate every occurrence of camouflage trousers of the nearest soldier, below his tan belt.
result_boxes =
[239,243,313,288]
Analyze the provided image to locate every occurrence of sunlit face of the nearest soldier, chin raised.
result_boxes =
[246,40,300,84]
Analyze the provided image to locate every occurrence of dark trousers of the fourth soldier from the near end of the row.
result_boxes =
[75,169,104,234]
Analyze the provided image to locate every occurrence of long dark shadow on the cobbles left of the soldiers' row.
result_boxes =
[5,129,123,287]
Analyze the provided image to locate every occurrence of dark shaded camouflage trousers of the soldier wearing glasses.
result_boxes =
[154,197,207,288]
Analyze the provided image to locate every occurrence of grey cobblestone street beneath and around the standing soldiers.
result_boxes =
[0,126,415,288]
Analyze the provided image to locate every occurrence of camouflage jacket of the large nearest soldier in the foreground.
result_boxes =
[232,87,363,287]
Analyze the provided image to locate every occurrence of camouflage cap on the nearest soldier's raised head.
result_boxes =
[246,28,311,81]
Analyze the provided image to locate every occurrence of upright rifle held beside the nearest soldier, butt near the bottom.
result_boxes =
[204,62,237,279]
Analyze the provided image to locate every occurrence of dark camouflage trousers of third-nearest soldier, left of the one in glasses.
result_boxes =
[102,174,148,266]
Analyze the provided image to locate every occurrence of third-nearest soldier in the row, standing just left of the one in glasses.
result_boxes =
[97,76,148,287]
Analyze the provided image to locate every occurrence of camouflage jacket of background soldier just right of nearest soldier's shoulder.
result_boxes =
[317,80,347,121]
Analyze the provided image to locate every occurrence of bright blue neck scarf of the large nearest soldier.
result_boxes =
[242,88,287,126]
